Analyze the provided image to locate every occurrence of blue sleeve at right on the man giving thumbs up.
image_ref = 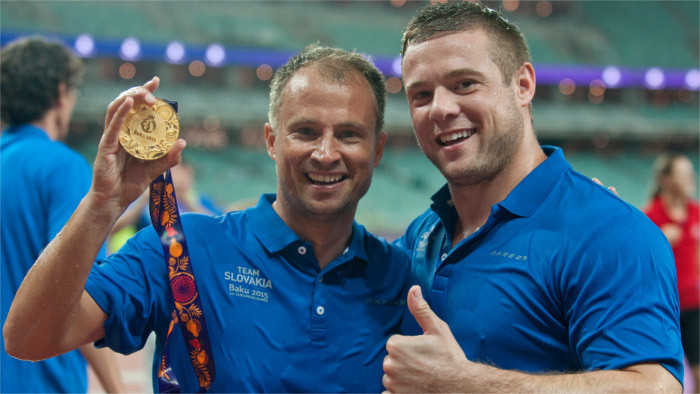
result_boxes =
[559,213,683,382]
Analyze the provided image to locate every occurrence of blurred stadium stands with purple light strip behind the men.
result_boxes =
[0,0,700,238]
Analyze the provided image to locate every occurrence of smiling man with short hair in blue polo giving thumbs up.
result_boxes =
[383,1,683,392]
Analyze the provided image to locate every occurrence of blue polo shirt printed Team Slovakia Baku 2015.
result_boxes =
[86,194,410,392]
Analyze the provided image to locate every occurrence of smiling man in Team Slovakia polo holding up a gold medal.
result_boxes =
[3,46,409,392]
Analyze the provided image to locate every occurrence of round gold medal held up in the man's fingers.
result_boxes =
[119,98,180,160]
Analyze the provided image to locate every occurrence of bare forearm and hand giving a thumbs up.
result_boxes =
[382,286,682,393]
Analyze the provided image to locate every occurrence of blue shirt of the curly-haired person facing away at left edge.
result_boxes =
[0,125,104,392]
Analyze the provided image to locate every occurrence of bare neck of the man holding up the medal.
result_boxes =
[272,201,355,269]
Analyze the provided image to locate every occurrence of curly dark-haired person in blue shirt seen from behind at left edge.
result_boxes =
[0,37,123,392]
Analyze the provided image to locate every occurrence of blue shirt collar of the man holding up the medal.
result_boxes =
[246,193,368,261]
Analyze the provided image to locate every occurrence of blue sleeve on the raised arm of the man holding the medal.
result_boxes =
[85,227,172,354]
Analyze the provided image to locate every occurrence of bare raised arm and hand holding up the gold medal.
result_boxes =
[3,78,185,360]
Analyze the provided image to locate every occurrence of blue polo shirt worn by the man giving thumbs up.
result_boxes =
[397,147,683,382]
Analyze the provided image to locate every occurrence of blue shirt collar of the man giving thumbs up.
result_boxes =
[431,146,571,219]
